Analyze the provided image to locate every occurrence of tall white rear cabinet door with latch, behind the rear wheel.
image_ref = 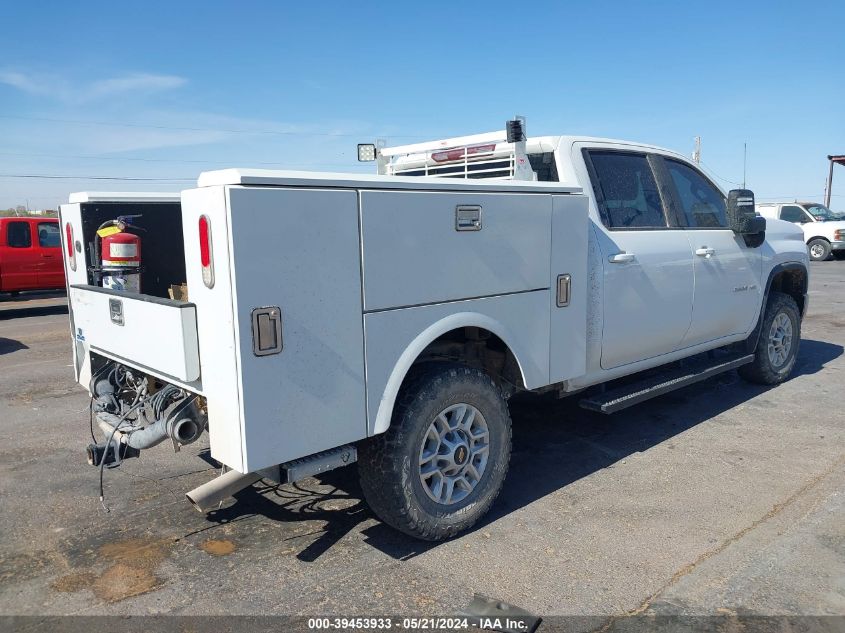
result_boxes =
[224,186,366,470]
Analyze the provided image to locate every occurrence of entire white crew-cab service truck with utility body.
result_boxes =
[61,126,808,540]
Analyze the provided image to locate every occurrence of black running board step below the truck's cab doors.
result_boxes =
[578,354,754,413]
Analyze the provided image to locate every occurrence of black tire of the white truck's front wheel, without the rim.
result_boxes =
[739,292,801,385]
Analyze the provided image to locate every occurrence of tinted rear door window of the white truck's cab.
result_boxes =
[589,151,666,229]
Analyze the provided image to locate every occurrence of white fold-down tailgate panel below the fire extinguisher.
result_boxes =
[69,285,200,382]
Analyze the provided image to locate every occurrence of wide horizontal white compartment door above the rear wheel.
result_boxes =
[361,191,552,311]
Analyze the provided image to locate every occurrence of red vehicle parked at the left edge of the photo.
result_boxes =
[0,217,65,294]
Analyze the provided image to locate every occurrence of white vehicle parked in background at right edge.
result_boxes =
[757,202,845,262]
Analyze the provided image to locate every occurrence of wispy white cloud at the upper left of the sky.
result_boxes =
[0,69,187,104]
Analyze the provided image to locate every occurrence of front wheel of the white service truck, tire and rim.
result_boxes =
[739,292,801,385]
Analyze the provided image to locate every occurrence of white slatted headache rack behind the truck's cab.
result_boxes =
[379,132,517,180]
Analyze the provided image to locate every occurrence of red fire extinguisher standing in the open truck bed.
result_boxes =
[97,215,141,292]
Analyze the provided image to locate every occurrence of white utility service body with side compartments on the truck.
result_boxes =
[62,175,588,473]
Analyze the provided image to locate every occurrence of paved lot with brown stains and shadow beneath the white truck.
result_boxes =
[0,261,845,623]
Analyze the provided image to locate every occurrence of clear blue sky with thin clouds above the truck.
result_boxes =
[0,0,845,210]
